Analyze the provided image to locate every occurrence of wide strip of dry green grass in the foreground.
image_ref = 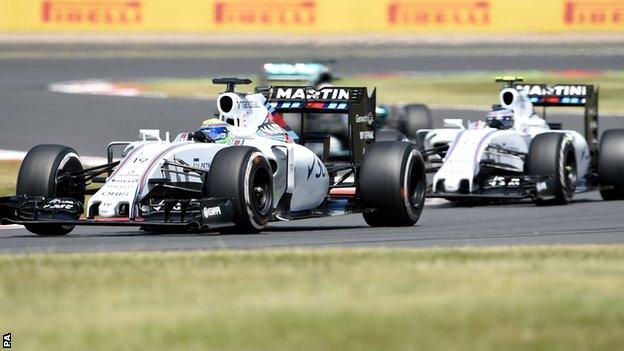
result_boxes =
[0,248,624,351]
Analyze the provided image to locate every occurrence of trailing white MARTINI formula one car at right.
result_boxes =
[418,77,624,204]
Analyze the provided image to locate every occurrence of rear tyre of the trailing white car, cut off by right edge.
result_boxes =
[598,129,624,200]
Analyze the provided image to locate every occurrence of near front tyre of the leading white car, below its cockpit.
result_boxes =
[204,146,273,234]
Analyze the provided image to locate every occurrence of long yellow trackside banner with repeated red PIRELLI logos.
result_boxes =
[0,0,624,35]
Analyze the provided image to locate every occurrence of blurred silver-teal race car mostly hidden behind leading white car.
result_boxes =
[263,61,433,142]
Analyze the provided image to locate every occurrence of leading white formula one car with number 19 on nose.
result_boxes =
[0,78,426,235]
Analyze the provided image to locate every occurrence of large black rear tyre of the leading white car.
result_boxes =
[358,141,427,227]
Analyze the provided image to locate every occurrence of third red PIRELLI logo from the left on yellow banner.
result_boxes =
[388,1,490,26]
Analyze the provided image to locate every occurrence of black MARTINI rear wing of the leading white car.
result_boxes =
[256,86,377,164]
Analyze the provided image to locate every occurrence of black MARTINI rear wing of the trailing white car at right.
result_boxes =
[513,83,598,167]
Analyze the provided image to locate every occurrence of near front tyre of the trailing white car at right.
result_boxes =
[526,133,578,205]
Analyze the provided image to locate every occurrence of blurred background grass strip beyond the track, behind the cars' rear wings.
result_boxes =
[125,71,624,114]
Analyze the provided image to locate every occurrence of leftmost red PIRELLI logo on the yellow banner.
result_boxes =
[41,0,142,25]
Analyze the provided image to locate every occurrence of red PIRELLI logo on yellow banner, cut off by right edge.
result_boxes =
[563,0,624,26]
